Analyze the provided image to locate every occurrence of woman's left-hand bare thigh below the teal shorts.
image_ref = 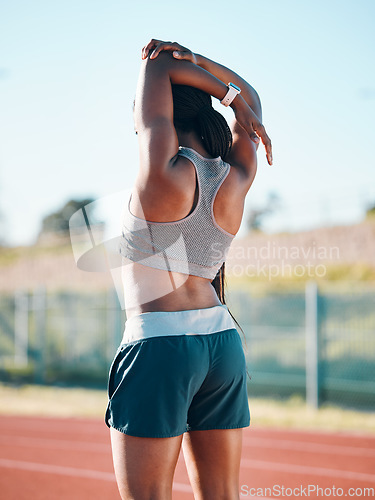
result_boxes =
[111,428,182,500]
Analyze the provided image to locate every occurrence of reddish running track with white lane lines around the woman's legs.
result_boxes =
[0,416,375,500]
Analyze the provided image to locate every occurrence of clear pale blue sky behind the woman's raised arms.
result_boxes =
[0,0,375,244]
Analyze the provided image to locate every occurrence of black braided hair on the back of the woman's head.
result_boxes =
[172,85,232,159]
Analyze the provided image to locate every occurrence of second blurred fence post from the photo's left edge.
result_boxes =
[33,286,47,384]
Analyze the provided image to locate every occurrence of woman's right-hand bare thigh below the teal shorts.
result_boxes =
[182,429,242,500]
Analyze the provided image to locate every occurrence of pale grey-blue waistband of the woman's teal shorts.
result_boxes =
[122,304,236,344]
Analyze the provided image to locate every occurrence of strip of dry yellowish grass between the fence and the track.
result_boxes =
[0,384,375,434]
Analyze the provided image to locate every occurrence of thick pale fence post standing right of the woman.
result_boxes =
[305,281,320,409]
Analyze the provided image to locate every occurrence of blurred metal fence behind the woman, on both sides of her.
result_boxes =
[0,283,375,409]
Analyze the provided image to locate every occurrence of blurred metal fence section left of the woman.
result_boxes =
[0,288,125,386]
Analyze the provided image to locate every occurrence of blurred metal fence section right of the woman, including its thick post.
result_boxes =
[226,283,375,409]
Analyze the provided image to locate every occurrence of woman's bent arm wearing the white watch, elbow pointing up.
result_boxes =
[134,52,270,180]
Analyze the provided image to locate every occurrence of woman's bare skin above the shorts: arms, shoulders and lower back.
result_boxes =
[124,40,272,317]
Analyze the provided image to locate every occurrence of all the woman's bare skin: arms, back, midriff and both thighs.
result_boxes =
[111,39,272,500]
